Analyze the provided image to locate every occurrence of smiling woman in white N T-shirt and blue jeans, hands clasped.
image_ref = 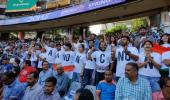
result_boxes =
[138,41,161,93]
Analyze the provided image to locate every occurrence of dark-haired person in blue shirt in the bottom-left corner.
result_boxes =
[2,72,26,100]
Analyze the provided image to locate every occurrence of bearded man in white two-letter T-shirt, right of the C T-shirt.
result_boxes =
[113,36,139,81]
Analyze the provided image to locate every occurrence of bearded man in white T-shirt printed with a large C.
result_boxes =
[91,42,112,85]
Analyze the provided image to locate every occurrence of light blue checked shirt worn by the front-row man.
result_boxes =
[115,77,152,100]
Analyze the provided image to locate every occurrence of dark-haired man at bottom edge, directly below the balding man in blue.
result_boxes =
[36,77,61,100]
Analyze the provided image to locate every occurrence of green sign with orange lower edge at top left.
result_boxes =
[6,0,37,12]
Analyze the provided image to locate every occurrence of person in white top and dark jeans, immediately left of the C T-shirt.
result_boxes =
[83,40,95,86]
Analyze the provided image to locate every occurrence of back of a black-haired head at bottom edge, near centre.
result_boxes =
[76,88,94,100]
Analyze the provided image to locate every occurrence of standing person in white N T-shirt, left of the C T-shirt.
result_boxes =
[73,44,86,82]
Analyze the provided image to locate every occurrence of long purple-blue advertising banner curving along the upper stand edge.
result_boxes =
[0,0,126,26]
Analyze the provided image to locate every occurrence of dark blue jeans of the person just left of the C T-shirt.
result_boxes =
[82,69,94,87]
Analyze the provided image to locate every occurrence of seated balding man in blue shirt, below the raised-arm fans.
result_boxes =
[55,66,69,97]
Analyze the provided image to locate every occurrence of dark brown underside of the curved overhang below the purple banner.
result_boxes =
[0,0,170,32]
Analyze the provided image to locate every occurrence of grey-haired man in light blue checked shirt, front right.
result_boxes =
[115,63,152,100]
